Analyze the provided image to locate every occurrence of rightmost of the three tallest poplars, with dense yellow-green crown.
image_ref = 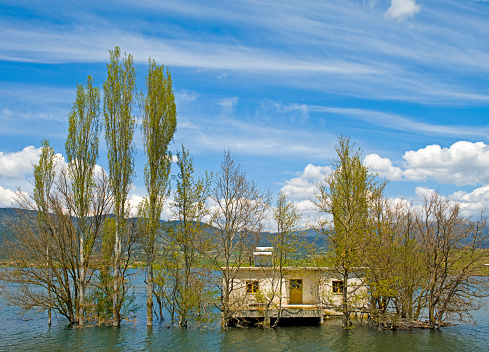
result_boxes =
[141,60,177,326]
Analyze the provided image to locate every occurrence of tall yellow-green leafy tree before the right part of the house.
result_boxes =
[316,136,384,329]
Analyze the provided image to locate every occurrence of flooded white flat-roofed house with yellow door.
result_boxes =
[225,266,367,324]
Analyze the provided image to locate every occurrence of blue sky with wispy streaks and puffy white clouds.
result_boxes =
[0,0,489,226]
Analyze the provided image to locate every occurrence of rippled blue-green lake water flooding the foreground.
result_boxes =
[0,270,489,352]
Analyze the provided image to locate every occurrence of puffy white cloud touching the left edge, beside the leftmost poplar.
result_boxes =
[0,145,41,178]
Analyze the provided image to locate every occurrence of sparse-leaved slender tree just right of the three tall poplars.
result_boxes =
[155,145,215,326]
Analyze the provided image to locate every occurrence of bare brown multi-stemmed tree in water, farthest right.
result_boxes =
[417,192,489,329]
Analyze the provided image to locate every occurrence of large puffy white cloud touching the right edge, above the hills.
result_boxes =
[403,141,489,185]
